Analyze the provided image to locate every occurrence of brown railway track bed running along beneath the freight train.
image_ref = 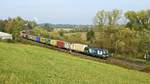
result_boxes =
[22,38,150,72]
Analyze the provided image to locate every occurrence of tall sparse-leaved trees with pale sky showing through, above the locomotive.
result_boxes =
[94,9,121,28]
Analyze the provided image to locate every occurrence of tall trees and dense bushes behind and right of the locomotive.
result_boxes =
[87,9,150,59]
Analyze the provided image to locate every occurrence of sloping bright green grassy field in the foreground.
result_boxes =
[0,42,150,84]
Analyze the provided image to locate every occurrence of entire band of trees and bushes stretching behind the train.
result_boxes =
[0,9,150,59]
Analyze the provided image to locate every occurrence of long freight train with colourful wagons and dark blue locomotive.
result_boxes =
[21,33,110,58]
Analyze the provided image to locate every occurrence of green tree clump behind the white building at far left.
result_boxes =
[0,17,37,41]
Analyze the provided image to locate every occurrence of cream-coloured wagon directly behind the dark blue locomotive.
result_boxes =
[71,44,88,52]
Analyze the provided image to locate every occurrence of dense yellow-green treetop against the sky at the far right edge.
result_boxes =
[125,10,150,31]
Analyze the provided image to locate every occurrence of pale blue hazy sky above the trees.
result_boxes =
[0,0,150,24]
